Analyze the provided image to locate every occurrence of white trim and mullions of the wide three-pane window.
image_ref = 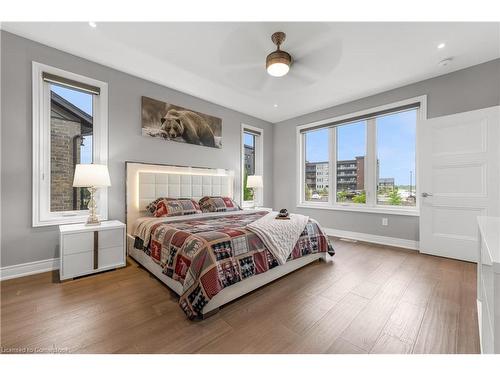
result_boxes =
[296,95,427,216]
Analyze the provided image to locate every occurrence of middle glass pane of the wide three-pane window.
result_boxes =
[336,121,366,203]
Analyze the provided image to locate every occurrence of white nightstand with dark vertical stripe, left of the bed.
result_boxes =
[59,220,126,280]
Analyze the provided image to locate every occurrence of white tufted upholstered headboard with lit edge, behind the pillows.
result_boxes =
[126,162,234,233]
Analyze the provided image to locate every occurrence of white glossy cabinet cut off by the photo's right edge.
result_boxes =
[477,216,500,354]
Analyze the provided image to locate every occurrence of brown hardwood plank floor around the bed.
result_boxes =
[0,240,479,353]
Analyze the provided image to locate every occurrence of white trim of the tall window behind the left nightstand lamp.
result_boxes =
[32,61,108,227]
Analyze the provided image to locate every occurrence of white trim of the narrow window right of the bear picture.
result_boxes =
[240,124,266,208]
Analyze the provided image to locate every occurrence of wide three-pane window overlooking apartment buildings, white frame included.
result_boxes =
[297,97,425,215]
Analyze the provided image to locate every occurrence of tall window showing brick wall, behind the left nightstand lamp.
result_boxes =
[33,62,107,226]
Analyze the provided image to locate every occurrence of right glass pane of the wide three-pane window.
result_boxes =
[376,109,417,206]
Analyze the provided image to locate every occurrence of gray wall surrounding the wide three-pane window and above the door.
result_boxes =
[273,59,500,241]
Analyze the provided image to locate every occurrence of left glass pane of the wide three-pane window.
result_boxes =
[304,128,330,202]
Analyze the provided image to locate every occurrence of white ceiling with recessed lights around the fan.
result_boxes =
[2,22,500,122]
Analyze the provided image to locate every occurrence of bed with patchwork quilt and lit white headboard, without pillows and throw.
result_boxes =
[126,162,334,319]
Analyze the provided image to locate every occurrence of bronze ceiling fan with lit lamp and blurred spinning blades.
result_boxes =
[220,24,342,91]
